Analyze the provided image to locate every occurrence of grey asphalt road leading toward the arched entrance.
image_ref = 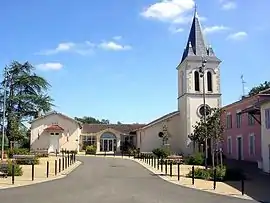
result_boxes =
[0,157,260,203]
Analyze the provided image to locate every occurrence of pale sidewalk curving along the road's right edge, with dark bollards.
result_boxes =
[79,155,253,200]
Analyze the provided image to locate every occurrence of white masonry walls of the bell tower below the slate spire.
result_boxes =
[178,57,221,154]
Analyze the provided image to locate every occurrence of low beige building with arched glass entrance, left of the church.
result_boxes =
[30,111,144,153]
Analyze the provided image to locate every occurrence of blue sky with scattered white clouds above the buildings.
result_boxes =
[0,0,270,123]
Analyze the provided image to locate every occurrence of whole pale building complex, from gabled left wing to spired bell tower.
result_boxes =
[30,8,221,154]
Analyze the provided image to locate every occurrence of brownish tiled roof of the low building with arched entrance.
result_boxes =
[82,124,145,134]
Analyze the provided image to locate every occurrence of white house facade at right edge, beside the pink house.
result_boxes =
[261,101,270,173]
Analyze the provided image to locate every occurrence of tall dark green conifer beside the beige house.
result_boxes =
[1,61,53,141]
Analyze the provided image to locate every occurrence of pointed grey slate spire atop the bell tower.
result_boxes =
[181,5,208,62]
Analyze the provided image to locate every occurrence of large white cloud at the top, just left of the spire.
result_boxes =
[141,0,195,23]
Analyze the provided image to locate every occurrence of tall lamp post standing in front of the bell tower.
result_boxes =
[199,58,208,168]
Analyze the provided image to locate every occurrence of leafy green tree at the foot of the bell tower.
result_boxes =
[189,108,224,167]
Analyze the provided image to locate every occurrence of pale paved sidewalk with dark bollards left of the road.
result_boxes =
[0,157,81,189]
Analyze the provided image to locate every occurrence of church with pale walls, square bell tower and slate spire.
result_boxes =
[137,11,221,154]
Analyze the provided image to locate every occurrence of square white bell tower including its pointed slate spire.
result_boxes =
[177,9,221,154]
